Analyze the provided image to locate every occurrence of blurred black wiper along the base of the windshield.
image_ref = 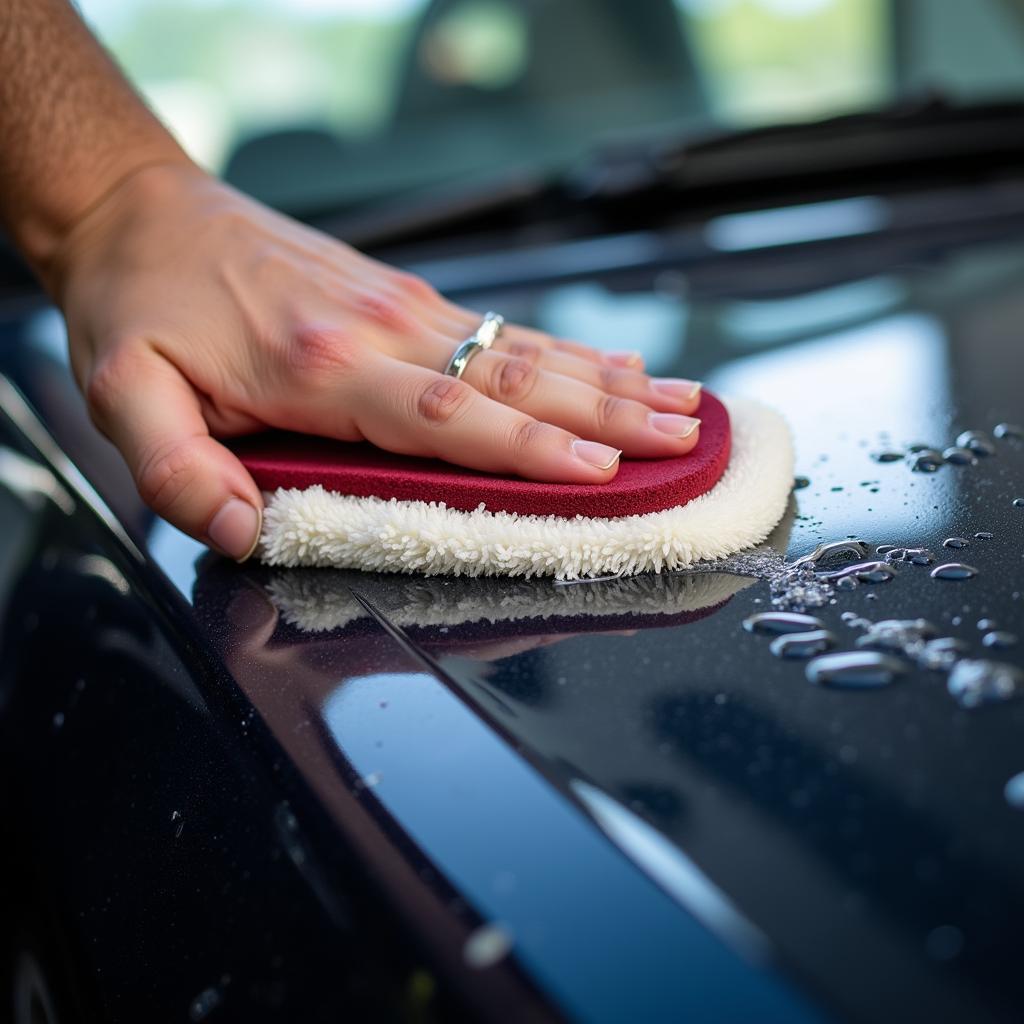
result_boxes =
[329,96,1024,247]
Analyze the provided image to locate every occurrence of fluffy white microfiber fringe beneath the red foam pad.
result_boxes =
[257,398,794,580]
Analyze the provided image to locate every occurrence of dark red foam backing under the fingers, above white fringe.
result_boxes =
[231,391,731,518]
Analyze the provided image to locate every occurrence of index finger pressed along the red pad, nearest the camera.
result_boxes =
[306,356,620,483]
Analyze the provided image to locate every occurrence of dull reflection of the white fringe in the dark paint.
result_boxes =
[266,571,754,633]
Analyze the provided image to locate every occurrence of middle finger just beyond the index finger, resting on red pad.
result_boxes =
[464,351,700,459]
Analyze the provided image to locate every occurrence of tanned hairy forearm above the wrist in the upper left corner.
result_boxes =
[0,0,187,289]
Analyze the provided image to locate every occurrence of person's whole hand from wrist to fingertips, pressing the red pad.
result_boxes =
[49,162,699,559]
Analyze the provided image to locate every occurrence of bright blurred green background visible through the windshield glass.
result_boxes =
[83,0,889,168]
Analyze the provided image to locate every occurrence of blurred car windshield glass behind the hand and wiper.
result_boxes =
[80,0,1024,213]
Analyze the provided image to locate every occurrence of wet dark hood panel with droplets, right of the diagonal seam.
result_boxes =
[188,232,1024,1020]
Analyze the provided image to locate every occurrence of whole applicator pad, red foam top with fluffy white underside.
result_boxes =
[234,392,793,580]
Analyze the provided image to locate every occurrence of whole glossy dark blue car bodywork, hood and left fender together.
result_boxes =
[0,172,1024,1022]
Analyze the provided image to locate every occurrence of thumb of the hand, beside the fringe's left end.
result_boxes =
[86,346,263,561]
